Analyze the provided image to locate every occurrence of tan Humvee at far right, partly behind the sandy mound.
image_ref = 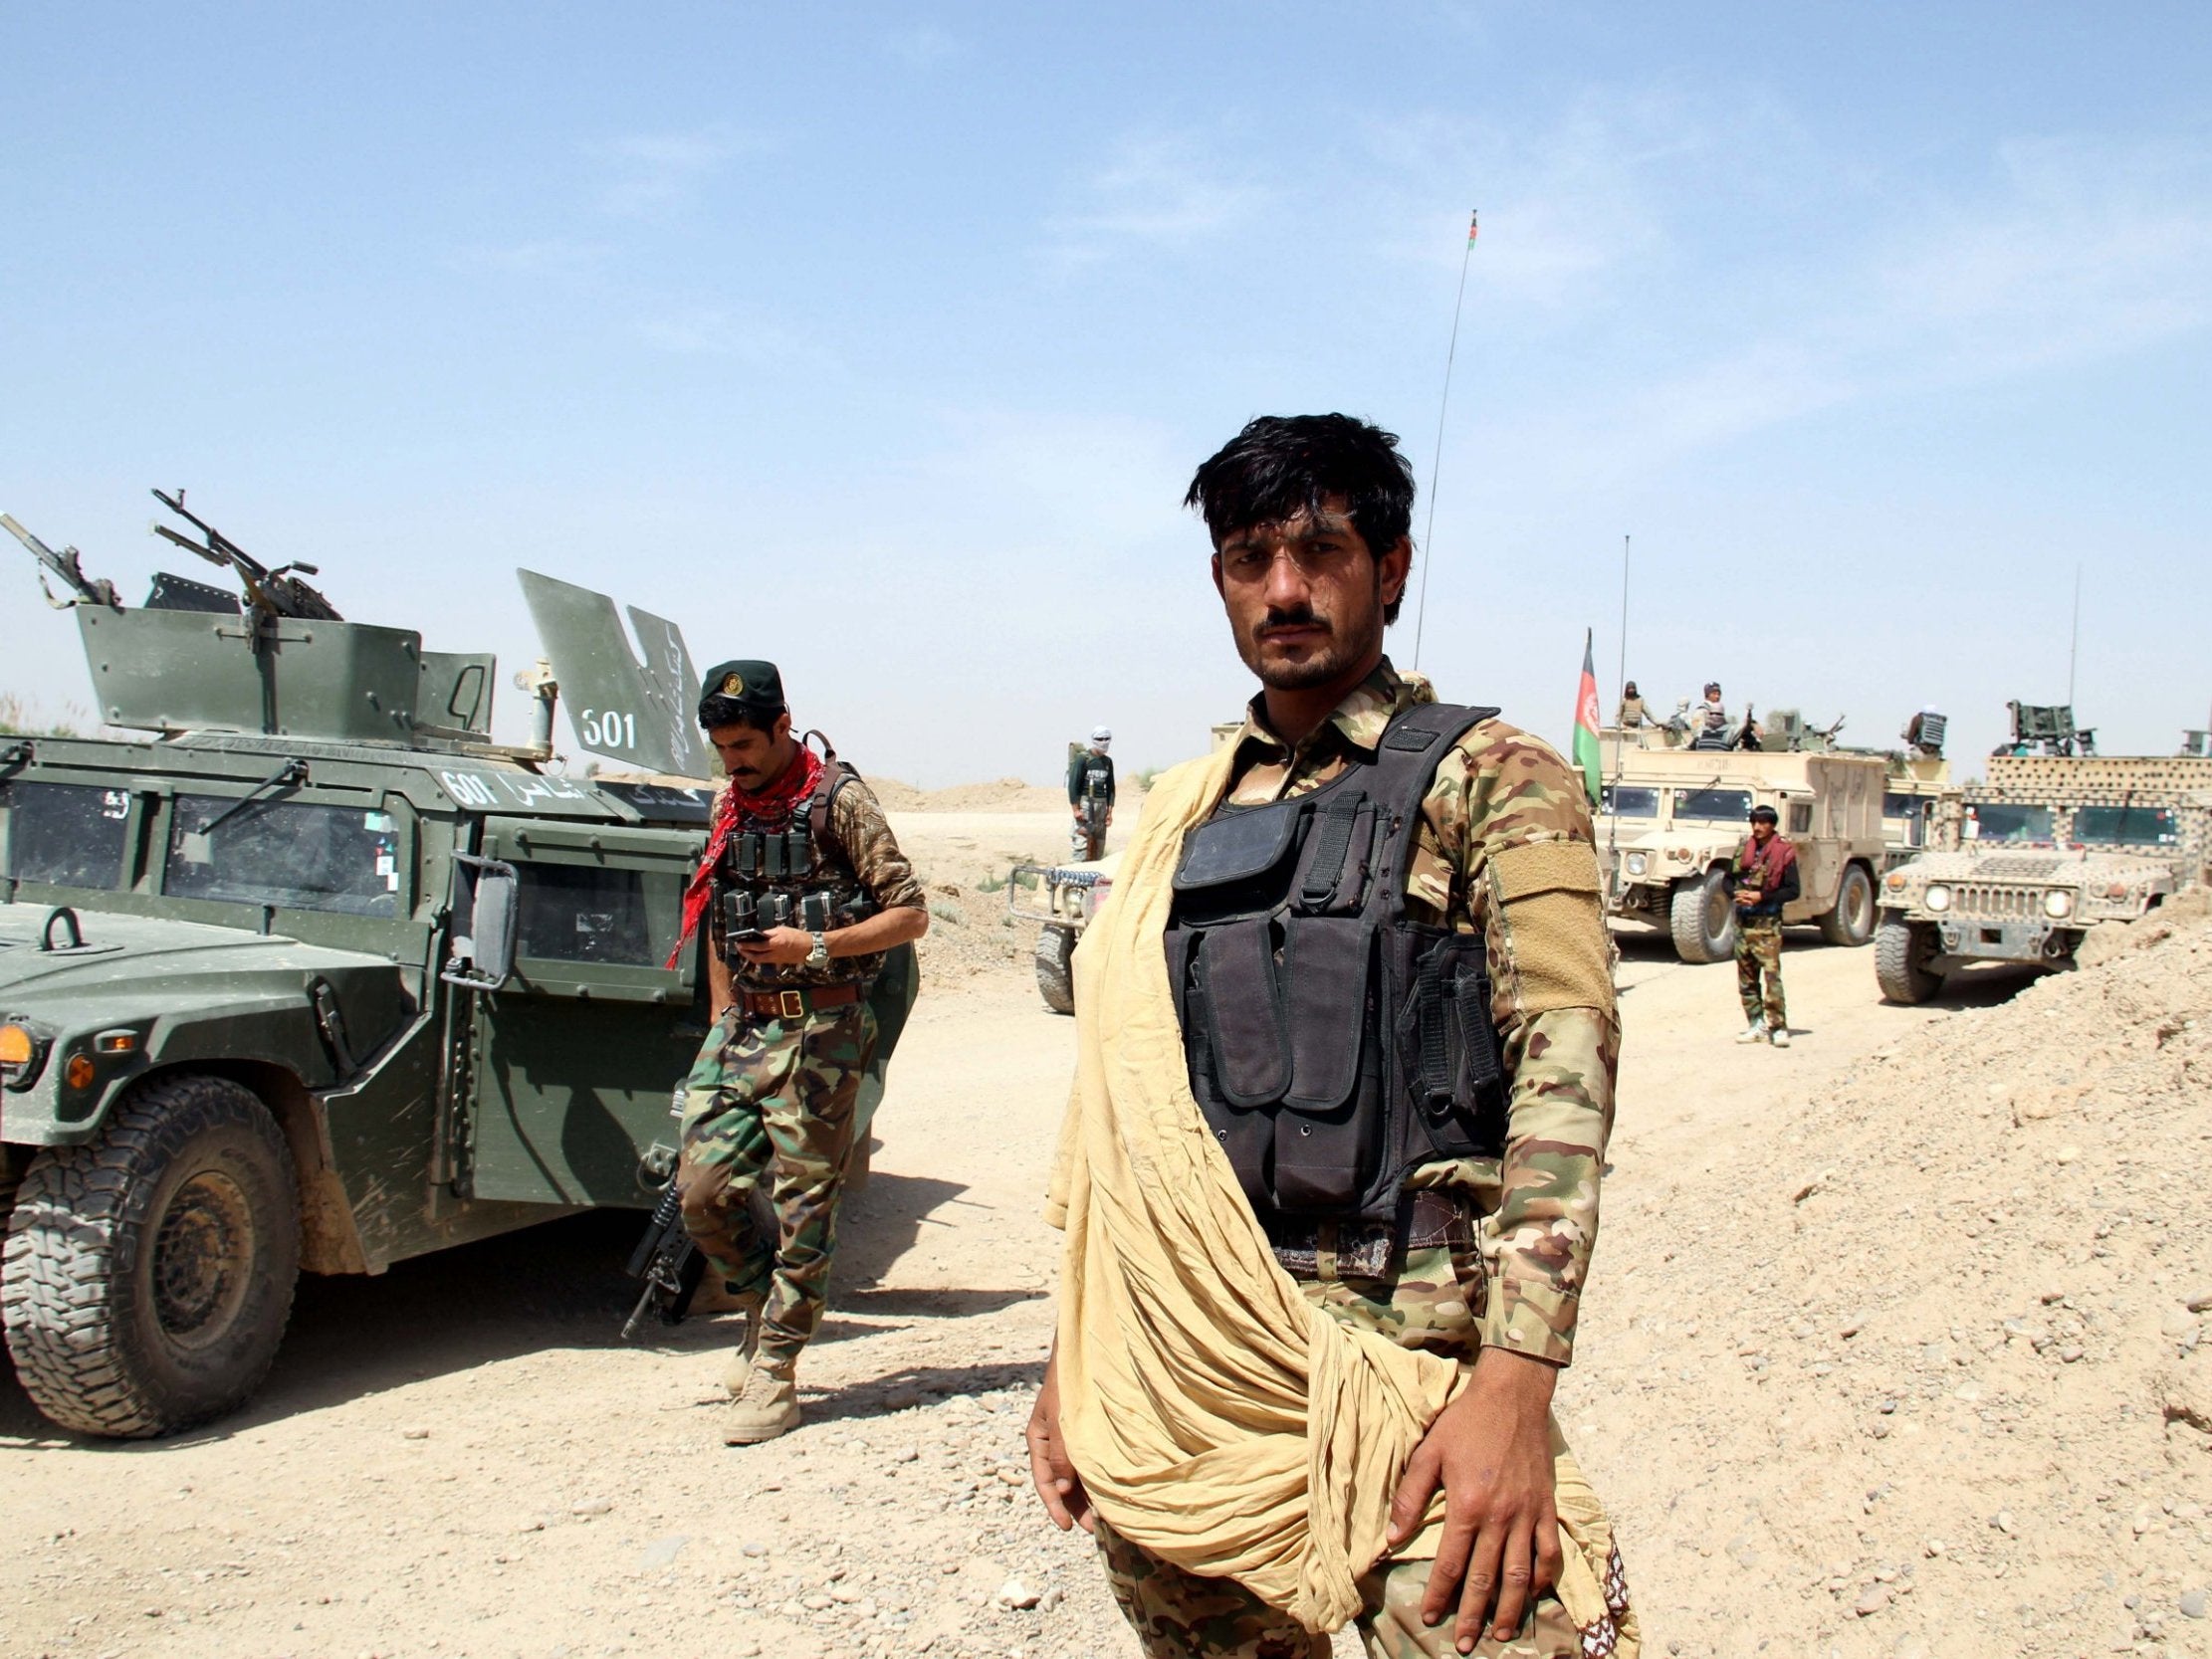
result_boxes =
[1874,754,2212,1002]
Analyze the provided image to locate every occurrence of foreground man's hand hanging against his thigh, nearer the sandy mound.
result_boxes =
[1389,1349,1560,1652]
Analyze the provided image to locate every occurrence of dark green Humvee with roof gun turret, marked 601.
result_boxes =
[0,498,710,1436]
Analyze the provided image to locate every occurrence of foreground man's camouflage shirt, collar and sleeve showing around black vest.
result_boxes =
[1225,657,1620,1364]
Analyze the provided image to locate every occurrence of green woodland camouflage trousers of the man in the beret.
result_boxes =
[677,1002,876,1369]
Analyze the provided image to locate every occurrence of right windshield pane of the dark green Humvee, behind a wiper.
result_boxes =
[161,794,400,916]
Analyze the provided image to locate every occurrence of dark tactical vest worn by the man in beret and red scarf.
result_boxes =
[715,732,883,984]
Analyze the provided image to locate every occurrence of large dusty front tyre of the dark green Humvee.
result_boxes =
[0,1077,299,1438]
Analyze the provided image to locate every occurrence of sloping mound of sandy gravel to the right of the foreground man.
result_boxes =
[1564,918,2212,1655]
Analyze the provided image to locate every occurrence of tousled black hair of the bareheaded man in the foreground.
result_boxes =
[1184,414,1414,622]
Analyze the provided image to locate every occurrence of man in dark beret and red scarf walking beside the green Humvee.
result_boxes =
[677,662,929,1447]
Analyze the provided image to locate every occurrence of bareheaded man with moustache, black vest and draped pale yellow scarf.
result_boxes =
[1028,416,1635,1659]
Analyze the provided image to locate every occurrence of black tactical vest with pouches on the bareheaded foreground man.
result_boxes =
[1166,704,1506,1221]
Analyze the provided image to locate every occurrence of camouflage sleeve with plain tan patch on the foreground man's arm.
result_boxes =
[1425,722,1620,1364]
